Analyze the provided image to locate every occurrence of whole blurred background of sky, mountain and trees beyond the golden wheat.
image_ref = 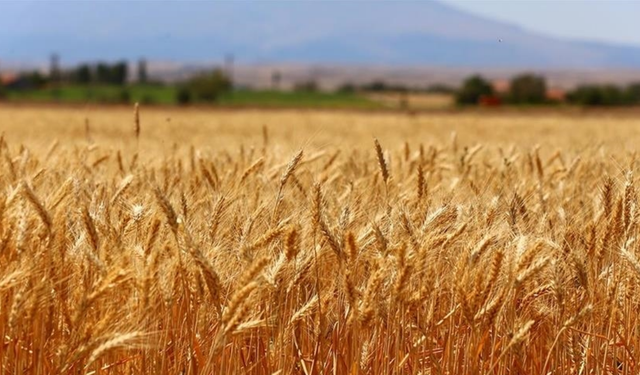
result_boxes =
[0,0,640,111]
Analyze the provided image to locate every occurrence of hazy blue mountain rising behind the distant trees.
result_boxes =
[0,1,640,68]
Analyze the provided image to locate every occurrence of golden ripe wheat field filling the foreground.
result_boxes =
[0,107,640,375]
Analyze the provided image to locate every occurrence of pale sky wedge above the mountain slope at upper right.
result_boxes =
[441,0,640,46]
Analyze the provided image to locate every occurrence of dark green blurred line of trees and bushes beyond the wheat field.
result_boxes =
[0,59,640,106]
